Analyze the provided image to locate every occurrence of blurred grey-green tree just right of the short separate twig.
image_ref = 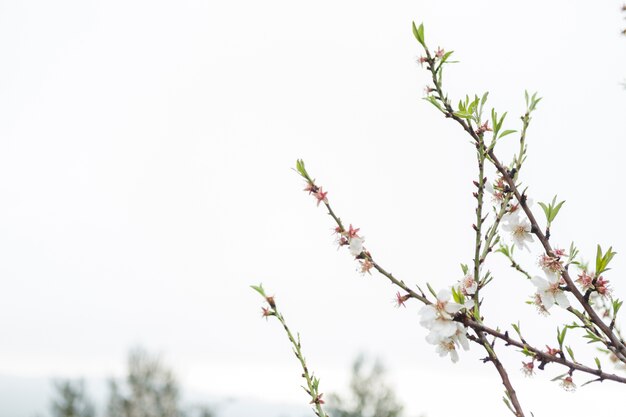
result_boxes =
[329,354,404,417]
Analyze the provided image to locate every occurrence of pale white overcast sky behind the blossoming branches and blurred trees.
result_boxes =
[0,0,626,416]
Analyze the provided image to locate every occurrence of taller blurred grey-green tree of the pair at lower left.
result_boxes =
[106,349,214,417]
